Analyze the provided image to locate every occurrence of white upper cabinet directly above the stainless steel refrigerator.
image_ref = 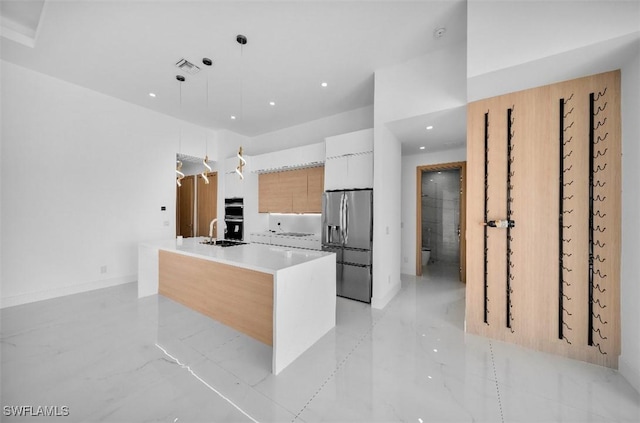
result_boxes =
[324,129,373,190]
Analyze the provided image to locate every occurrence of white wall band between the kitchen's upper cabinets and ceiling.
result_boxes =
[247,106,373,156]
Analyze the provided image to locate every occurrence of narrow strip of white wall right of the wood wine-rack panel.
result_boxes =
[619,45,640,392]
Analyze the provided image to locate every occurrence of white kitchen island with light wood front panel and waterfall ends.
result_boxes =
[138,237,336,374]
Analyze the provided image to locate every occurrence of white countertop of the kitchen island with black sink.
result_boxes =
[143,237,334,274]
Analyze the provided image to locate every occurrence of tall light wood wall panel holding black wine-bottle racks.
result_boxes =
[466,71,621,367]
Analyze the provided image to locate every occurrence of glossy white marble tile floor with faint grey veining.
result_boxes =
[0,265,640,423]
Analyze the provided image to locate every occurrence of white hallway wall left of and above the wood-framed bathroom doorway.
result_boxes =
[401,148,467,275]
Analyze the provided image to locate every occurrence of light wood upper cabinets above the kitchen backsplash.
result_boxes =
[258,167,324,213]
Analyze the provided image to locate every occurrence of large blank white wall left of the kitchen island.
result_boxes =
[0,61,215,307]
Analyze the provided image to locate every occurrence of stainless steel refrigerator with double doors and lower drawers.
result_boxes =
[322,189,373,303]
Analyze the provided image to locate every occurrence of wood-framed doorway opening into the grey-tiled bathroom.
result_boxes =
[416,162,466,282]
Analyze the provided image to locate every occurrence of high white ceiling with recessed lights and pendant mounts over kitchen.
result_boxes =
[1,0,466,149]
